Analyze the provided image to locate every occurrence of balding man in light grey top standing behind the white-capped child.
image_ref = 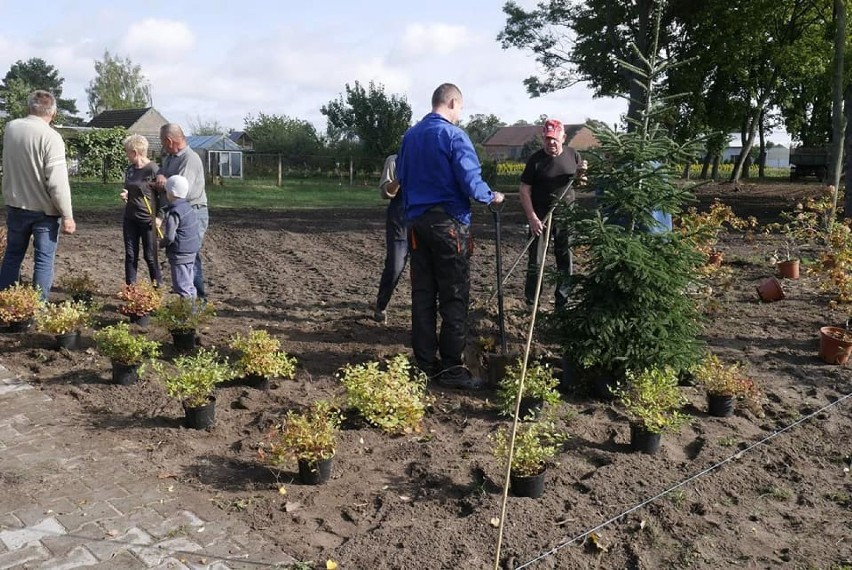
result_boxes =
[156,123,210,300]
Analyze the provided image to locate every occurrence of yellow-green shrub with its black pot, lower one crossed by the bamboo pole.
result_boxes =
[492,421,567,499]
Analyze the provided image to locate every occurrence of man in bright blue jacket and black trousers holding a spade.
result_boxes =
[396,83,504,390]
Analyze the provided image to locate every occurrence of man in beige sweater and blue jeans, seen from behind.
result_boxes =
[0,90,76,300]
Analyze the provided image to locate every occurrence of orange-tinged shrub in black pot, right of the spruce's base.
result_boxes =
[690,353,760,418]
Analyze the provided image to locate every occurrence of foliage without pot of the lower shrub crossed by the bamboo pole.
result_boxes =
[491,421,568,477]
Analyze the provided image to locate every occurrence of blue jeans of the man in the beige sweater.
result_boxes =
[0,206,59,301]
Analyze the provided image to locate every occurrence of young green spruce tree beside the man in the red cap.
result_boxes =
[553,5,704,381]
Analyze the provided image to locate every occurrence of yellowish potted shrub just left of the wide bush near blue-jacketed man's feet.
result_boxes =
[229,330,296,389]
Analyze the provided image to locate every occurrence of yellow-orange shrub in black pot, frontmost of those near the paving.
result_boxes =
[266,400,343,485]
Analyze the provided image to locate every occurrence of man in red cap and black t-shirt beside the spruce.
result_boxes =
[520,119,583,309]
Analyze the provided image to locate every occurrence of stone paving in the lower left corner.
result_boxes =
[0,365,296,570]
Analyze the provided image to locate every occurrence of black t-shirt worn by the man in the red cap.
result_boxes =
[521,146,582,218]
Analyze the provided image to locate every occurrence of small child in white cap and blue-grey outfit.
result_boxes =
[160,174,201,299]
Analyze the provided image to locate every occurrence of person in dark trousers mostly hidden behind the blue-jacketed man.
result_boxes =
[373,154,408,323]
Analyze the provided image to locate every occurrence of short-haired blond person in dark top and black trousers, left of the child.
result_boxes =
[121,135,163,287]
